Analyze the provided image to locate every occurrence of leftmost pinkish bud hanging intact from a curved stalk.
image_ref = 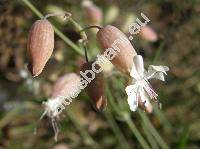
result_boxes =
[27,19,54,77]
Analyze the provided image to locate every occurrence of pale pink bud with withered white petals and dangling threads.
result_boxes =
[41,73,80,140]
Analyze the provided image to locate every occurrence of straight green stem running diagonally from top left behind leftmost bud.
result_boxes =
[21,0,84,56]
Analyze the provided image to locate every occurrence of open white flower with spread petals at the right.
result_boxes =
[125,55,169,111]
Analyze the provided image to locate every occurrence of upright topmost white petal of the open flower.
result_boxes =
[133,55,144,76]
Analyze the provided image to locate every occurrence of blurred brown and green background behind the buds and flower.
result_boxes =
[0,0,200,149]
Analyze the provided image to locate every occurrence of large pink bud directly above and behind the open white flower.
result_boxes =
[97,25,137,74]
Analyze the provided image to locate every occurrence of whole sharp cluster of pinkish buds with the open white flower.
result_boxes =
[28,6,169,139]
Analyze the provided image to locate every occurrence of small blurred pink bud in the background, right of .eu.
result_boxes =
[139,26,158,42]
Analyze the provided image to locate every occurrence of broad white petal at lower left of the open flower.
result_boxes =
[128,92,138,111]
